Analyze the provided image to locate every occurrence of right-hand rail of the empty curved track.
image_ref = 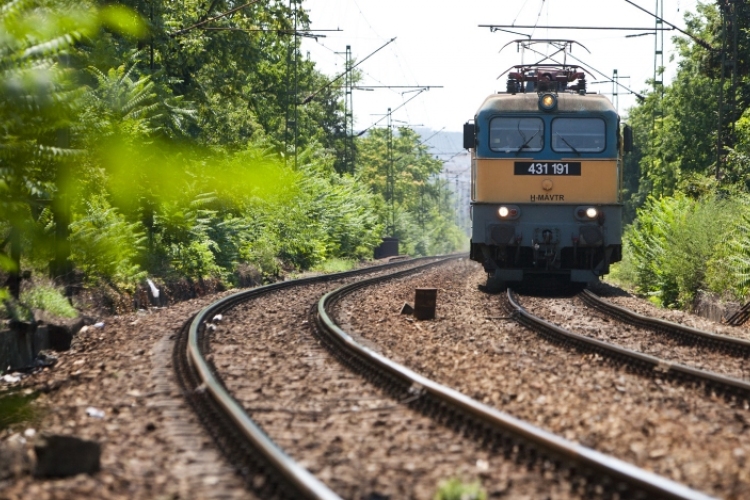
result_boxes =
[316,268,712,500]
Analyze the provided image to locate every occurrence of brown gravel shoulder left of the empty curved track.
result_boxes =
[0,293,251,500]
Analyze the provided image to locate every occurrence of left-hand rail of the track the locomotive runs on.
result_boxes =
[508,289,750,400]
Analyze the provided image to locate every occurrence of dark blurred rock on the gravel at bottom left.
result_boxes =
[34,435,102,477]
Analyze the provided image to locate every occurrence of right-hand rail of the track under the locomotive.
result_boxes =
[579,290,750,356]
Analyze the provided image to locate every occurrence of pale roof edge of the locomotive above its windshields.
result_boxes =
[477,92,615,115]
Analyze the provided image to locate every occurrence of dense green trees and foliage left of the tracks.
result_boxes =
[0,0,463,308]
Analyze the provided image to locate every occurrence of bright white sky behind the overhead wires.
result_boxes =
[302,0,697,132]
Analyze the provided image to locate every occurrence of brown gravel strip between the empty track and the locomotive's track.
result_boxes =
[338,263,750,499]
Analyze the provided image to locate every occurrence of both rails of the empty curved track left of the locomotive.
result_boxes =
[175,262,720,498]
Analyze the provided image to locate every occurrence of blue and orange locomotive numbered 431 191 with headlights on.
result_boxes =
[464,41,632,288]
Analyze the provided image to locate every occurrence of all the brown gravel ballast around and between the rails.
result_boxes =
[0,260,750,499]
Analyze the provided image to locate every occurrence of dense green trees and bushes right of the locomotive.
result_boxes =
[618,2,750,308]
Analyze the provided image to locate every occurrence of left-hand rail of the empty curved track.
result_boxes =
[186,257,447,500]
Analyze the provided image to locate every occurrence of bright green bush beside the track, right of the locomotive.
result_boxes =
[615,194,750,308]
